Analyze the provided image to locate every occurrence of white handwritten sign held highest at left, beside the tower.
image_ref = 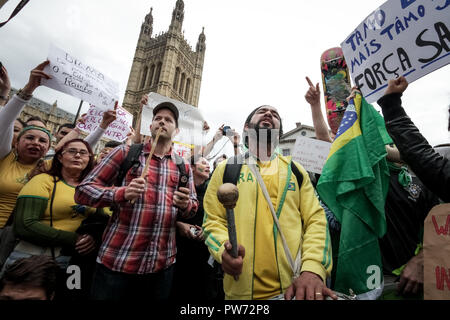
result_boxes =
[42,46,119,110]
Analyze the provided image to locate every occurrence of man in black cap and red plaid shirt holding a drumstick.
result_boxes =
[75,102,198,300]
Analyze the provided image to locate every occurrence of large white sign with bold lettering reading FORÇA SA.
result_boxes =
[341,0,450,103]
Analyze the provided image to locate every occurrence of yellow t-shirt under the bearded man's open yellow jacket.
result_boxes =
[250,157,281,299]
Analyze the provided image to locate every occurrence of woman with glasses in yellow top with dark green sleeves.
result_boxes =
[4,139,95,268]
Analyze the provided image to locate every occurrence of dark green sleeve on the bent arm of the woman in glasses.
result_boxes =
[14,197,78,247]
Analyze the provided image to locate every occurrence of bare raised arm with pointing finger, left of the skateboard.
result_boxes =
[305,77,333,142]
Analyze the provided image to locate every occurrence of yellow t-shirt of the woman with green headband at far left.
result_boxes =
[0,151,35,228]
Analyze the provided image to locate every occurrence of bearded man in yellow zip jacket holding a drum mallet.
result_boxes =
[203,106,336,300]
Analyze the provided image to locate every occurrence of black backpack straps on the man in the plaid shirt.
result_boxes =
[114,143,189,188]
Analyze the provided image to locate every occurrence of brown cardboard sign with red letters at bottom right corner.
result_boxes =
[423,203,450,300]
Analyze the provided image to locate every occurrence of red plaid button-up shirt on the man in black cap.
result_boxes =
[75,143,198,274]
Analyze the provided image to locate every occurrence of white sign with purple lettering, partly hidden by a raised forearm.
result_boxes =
[77,105,133,142]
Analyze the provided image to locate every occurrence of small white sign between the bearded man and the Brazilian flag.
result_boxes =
[292,137,331,174]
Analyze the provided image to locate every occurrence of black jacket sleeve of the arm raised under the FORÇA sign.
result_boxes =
[378,93,450,202]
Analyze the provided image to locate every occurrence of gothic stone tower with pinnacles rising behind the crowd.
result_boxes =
[123,0,206,119]
